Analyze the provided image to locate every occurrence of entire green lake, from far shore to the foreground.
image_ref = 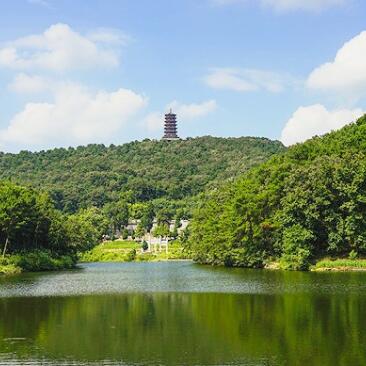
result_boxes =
[0,262,366,366]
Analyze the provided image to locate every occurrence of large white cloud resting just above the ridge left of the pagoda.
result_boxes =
[0,83,147,149]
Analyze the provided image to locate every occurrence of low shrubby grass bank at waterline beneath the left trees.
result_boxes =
[0,250,77,275]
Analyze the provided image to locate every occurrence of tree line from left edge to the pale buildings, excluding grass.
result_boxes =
[0,181,184,259]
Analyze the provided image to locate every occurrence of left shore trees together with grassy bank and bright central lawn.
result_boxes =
[0,182,192,274]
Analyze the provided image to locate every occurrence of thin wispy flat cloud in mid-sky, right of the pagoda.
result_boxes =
[204,68,295,93]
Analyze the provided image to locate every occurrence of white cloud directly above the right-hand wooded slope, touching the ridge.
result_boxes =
[281,104,364,146]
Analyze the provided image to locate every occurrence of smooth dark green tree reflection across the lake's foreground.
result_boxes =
[0,293,366,366]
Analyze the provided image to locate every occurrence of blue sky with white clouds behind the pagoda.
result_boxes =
[0,0,366,152]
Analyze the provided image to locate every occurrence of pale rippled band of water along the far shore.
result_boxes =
[0,262,366,298]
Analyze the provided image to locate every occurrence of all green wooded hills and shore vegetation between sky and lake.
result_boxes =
[0,117,366,270]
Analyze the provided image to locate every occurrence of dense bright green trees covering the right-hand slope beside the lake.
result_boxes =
[190,117,366,269]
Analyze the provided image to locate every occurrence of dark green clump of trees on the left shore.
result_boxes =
[0,182,108,260]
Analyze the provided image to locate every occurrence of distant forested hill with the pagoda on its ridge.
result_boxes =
[0,137,284,212]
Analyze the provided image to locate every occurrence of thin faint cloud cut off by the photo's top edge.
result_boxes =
[211,0,346,13]
